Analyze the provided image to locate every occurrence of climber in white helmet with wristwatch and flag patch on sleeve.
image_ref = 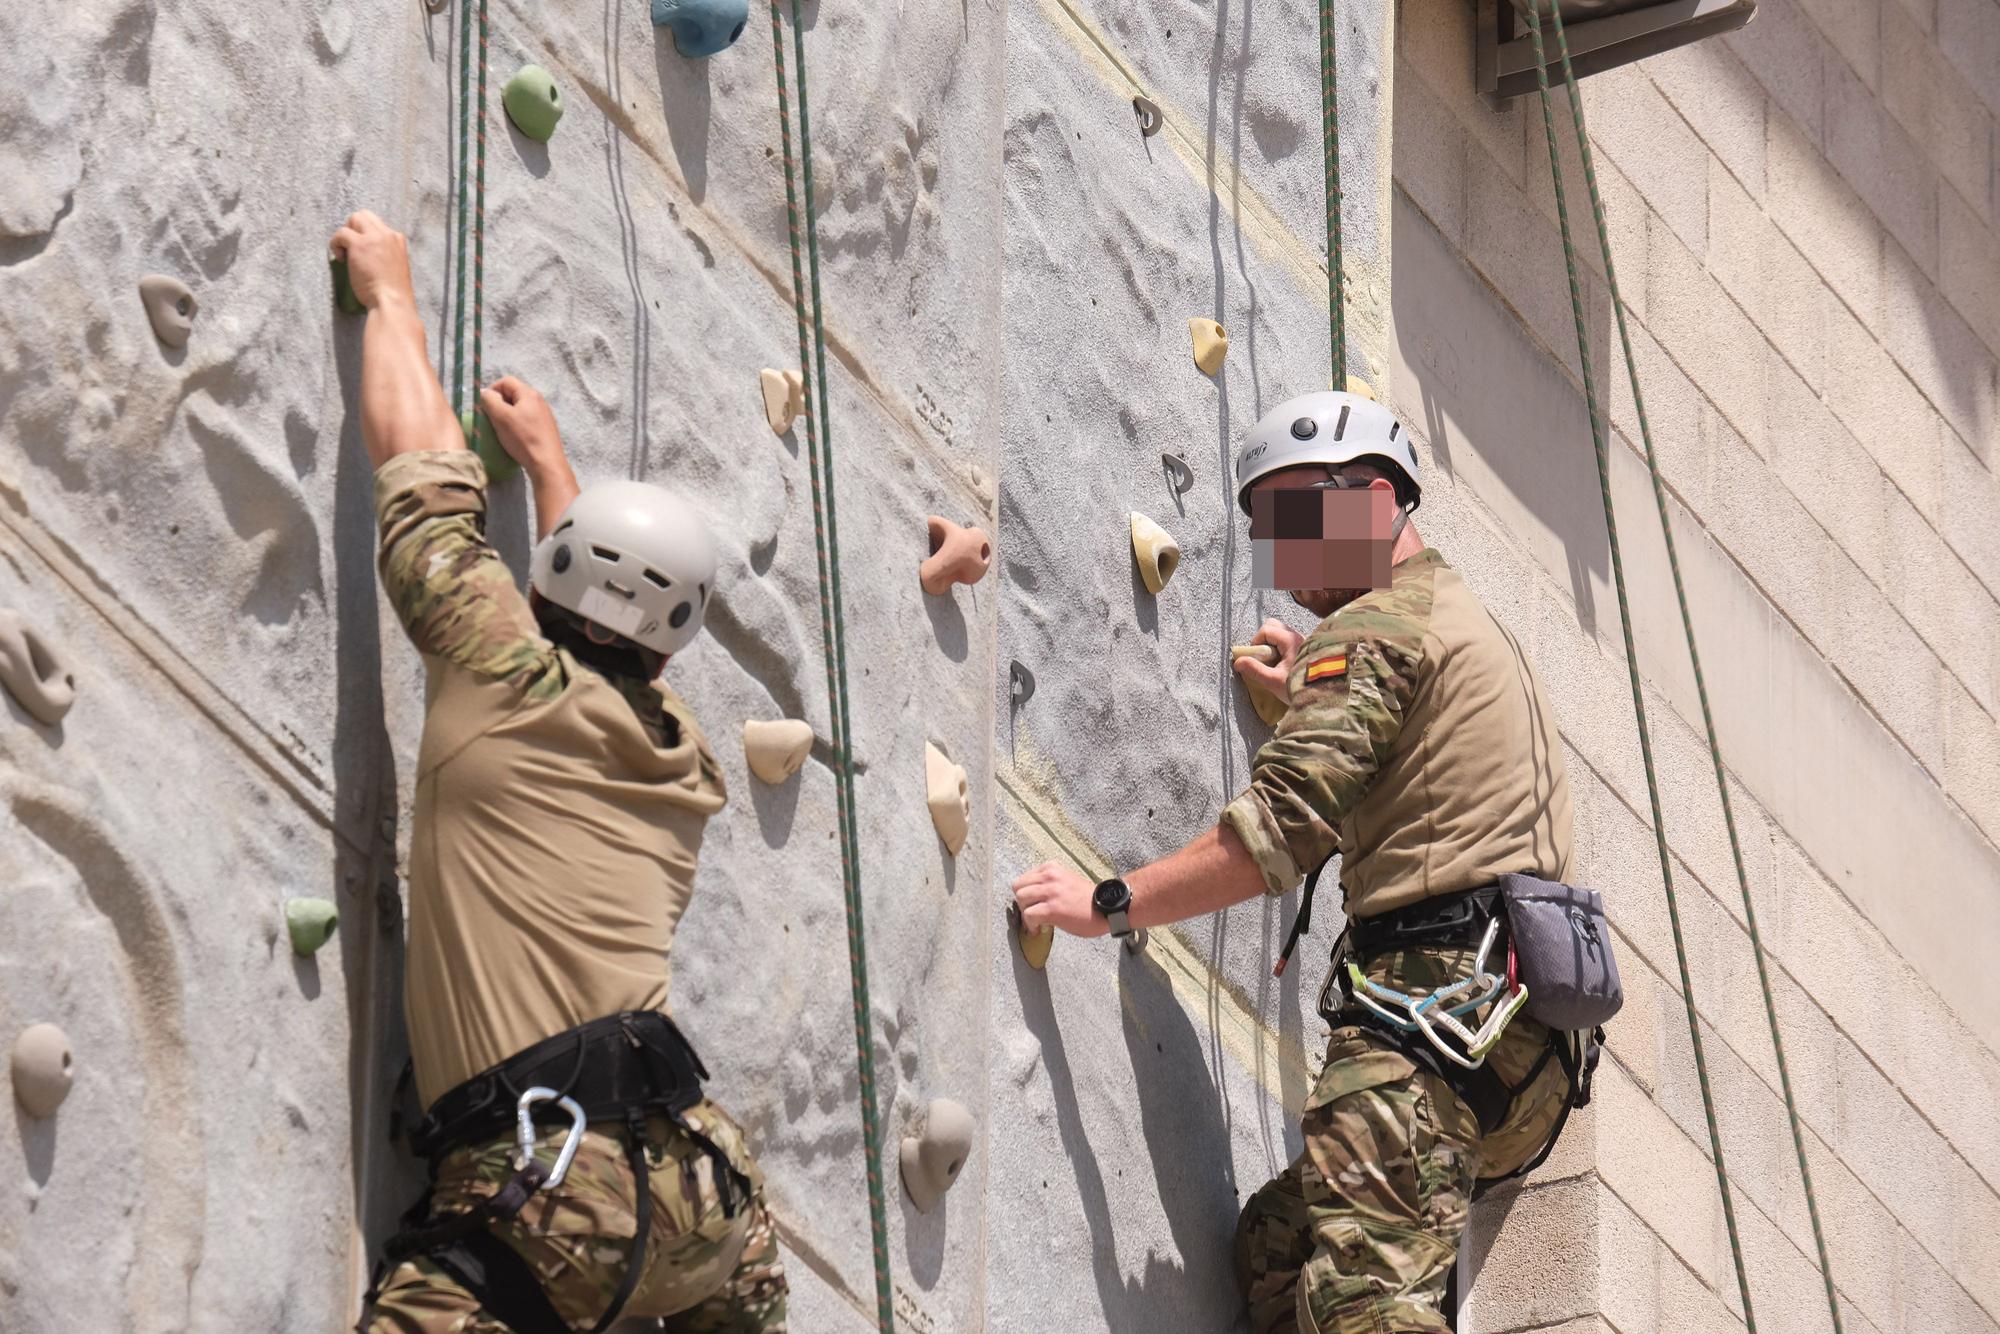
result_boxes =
[1014,392,1588,1334]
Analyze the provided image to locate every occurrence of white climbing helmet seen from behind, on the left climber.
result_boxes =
[528,480,716,654]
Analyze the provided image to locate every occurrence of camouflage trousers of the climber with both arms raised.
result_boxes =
[362,1102,788,1334]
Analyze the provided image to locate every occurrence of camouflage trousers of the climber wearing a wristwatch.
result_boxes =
[1236,948,1568,1334]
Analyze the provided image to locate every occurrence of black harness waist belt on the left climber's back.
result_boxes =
[410,1010,708,1162]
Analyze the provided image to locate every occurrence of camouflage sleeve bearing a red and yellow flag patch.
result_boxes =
[1222,616,1424,894]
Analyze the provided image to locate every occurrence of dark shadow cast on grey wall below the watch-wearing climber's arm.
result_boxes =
[1010,950,1242,1330]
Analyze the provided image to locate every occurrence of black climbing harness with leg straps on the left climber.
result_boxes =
[358,1010,752,1334]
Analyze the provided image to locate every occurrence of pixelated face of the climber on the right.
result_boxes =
[1250,466,1396,616]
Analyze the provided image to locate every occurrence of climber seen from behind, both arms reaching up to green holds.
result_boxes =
[332,212,786,1334]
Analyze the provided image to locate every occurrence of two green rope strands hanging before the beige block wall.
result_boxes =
[1526,4,1842,1334]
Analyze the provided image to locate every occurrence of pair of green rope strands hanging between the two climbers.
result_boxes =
[770,0,896,1334]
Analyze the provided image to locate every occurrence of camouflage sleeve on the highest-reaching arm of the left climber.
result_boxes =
[376,450,562,688]
